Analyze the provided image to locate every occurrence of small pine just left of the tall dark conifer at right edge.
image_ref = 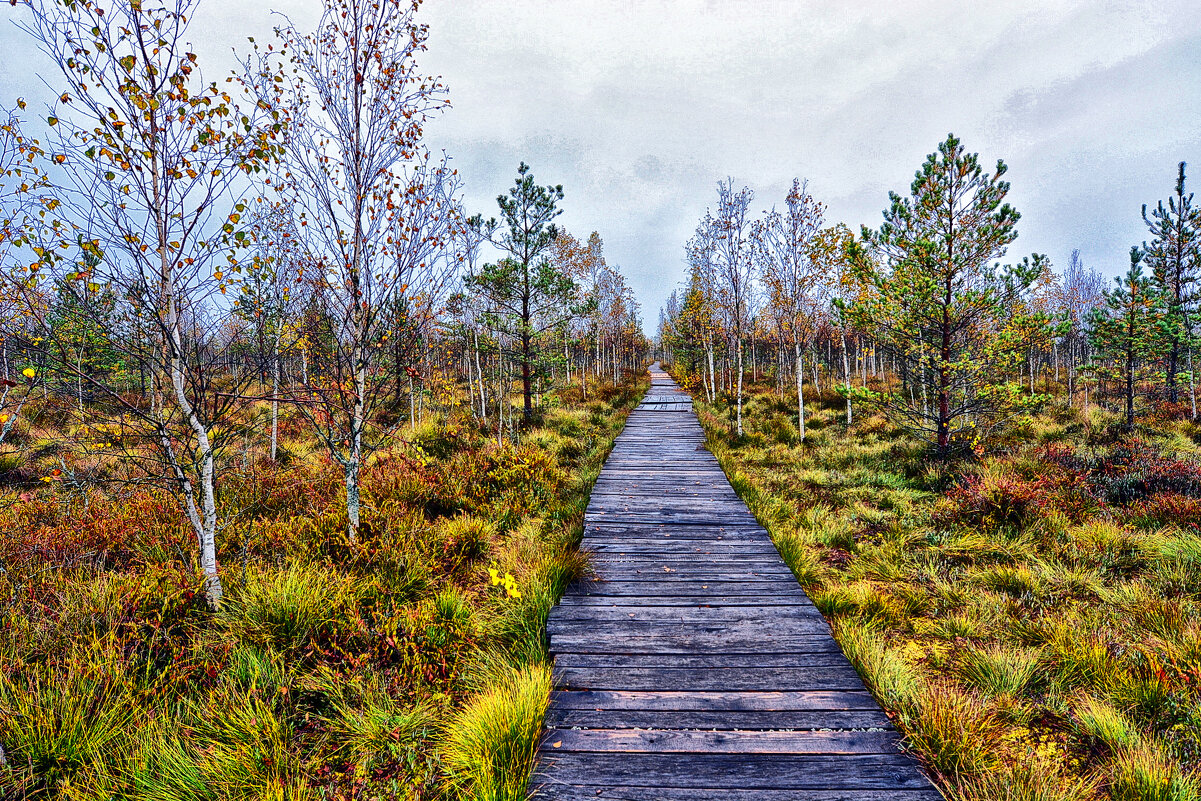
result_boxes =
[1089,246,1171,428]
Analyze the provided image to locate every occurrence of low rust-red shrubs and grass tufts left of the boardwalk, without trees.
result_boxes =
[0,378,646,801]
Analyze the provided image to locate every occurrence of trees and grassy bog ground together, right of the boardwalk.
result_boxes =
[659,136,1201,801]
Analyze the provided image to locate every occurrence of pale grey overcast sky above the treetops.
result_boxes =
[0,0,1201,329]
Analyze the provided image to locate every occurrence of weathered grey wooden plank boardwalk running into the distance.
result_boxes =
[531,365,942,801]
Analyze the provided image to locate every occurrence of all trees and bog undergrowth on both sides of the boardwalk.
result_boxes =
[0,0,1201,801]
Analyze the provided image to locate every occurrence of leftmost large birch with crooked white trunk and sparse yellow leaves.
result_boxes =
[20,0,280,605]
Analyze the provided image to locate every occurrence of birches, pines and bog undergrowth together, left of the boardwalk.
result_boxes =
[0,0,647,801]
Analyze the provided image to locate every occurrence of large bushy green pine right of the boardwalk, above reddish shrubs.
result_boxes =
[848,135,1042,455]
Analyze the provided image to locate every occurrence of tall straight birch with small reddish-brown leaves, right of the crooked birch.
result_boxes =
[245,0,461,542]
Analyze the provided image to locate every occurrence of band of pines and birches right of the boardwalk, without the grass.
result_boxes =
[659,135,1201,456]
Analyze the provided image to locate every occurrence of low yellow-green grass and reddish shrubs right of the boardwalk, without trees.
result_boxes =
[698,377,1201,801]
